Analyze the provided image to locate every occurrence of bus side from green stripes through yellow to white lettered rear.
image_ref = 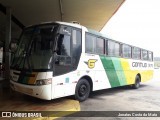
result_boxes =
[100,56,153,87]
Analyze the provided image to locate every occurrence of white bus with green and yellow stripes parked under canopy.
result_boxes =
[10,21,154,101]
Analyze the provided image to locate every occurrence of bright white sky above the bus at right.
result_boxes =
[101,0,160,57]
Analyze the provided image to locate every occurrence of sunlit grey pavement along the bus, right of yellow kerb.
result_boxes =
[62,70,160,120]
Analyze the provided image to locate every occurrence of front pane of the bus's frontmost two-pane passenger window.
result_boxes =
[85,34,96,53]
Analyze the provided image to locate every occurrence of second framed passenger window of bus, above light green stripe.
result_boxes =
[108,41,120,56]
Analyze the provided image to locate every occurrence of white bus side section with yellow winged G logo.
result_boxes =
[77,53,111,91]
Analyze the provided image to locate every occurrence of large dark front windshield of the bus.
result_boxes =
[11,24,58,69]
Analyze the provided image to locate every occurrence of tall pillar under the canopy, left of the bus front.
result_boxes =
[4,7,11,85]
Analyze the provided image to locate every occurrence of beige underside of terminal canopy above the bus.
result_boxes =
[0,0,125,31]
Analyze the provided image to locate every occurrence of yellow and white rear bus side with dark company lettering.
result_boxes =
[121,58,153,84]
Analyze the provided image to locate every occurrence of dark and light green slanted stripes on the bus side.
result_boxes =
[100,56,127,87]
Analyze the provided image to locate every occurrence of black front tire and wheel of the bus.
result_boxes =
[75,79,91,102]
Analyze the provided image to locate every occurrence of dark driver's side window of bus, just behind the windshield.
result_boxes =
[54,26,73,76]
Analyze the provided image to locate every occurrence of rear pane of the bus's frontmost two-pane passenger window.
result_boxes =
[96,38,104,54]
